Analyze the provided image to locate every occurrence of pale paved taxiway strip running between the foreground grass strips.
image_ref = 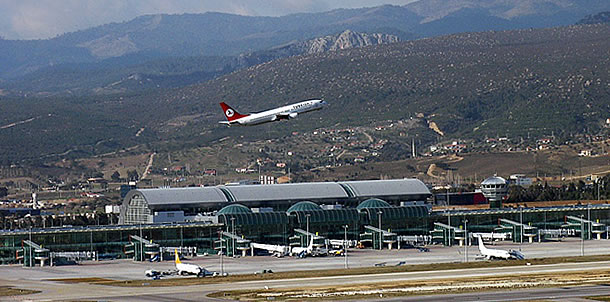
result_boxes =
[1,261,610,301]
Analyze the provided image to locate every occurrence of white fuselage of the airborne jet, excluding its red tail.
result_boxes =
[231,100,326,126]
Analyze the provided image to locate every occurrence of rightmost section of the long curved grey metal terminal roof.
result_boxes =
[342,178,431,197]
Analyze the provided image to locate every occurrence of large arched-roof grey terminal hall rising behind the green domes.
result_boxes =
[119,179,431,224]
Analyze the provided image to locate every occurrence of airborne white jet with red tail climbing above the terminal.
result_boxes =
[218,100,328,126]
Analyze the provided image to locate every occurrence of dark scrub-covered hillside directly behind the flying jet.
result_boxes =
[0,25,610,162]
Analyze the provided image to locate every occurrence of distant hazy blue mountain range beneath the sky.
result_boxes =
[0,0,610,94]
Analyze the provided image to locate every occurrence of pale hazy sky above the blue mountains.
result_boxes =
[0,0,414,39]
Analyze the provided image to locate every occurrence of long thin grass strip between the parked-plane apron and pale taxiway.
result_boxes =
[98,255,610,287]
